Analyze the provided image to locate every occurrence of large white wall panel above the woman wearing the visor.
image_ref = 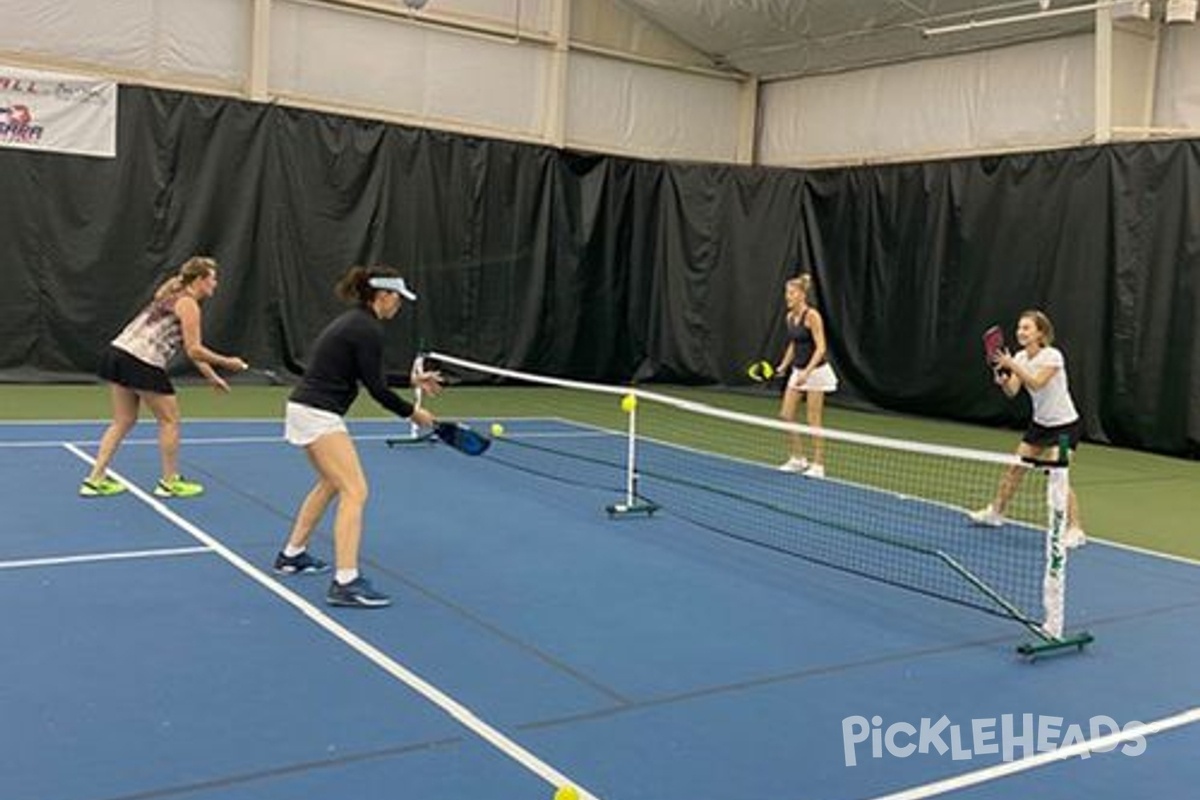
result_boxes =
[269,2,550,138]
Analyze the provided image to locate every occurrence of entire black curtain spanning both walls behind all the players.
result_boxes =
[0,88,1200,456]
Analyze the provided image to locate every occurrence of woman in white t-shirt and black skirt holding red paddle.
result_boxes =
[971,311,1087,547]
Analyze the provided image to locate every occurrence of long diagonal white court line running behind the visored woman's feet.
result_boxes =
[60,443,600,800]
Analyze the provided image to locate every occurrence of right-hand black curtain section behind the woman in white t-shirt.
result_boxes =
[804,142,1200,456]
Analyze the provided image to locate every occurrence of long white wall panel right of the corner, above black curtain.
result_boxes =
[758,36,1096,166]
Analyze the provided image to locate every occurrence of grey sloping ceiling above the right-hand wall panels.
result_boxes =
[620,0,1118,79]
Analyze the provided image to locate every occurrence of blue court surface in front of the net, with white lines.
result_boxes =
[0,421,1200,800]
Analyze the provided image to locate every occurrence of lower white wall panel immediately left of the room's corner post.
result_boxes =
[566,53,739,162]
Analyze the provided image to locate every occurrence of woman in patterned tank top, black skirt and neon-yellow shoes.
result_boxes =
[79,255,248,498]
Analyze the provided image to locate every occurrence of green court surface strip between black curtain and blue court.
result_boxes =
[0,384,1200,559]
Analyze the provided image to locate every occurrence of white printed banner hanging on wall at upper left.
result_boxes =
[0,64,116,158]
